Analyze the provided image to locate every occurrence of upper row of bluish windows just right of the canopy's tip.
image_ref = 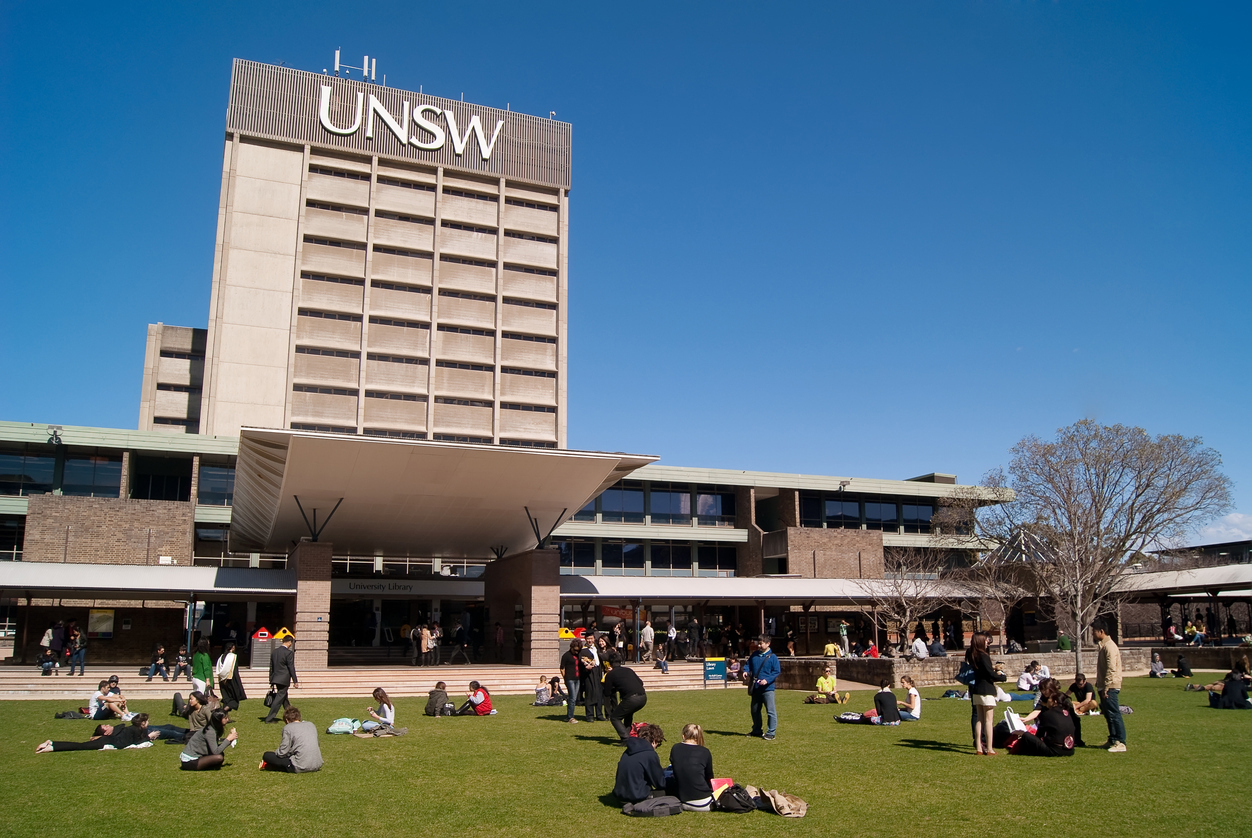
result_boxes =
[573,480,735,526]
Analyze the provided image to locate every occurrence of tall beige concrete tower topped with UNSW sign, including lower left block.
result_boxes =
[140,60,571,448]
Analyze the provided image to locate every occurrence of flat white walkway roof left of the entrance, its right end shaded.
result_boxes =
[0,561,295,601]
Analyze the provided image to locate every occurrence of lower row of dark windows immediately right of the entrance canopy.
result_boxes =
[555,539,739,576]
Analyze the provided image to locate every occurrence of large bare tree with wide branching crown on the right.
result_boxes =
[975,420,1231,671]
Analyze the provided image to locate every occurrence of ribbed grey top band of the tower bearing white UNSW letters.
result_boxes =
[227,59,571,189]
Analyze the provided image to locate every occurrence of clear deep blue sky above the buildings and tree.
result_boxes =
[0,3,1252,541]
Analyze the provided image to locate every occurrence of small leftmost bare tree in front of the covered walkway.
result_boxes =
[858,547,965,651]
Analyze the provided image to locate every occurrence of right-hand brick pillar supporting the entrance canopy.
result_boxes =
[483,550,561,669]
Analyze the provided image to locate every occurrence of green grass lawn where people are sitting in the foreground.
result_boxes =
[0,679,1252,838]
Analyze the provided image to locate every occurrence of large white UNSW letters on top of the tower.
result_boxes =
[318,84,505,160]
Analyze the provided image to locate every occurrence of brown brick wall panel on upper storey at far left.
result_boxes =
[23,495,195,566]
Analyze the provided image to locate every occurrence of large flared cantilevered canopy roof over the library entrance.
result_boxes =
[230,428,656,559]
